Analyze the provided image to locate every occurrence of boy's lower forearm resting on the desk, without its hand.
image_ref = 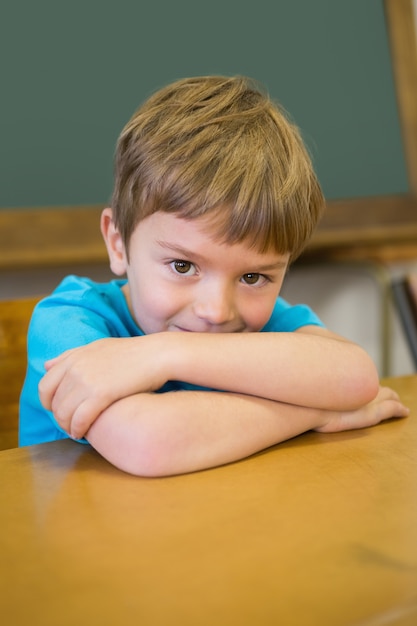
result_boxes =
[87,391,325,476]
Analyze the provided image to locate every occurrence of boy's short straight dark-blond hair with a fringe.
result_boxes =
[112,76,324,259]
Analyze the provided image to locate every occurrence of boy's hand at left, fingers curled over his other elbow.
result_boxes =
[39,334,168,439]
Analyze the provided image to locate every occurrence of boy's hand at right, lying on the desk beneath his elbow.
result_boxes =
[314,387,410,433]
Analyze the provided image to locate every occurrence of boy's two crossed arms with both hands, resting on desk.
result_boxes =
[39,327,407,475]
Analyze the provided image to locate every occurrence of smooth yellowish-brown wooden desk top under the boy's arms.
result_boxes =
[0,377,417,626]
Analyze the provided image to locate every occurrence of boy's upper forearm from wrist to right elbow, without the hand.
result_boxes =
[167,333,378,410]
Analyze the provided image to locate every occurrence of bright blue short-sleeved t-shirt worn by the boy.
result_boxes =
[19,276,323,446]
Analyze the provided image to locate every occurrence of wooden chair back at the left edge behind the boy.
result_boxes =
[0,297,40,450]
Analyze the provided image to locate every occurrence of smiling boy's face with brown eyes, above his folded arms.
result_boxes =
[120,212,289,334]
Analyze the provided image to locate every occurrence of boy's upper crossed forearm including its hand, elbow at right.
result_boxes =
[39,329,378,438]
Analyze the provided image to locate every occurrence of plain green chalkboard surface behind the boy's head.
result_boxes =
[0,0,408,208]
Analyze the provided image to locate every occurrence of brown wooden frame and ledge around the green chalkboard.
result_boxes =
[0,0,417,270]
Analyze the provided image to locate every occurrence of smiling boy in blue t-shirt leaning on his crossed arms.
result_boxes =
[20,77,407,476]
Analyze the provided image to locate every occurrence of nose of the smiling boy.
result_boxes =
[194,281,237,325]
